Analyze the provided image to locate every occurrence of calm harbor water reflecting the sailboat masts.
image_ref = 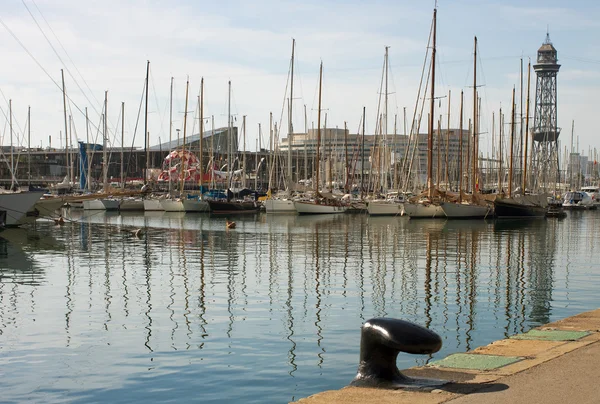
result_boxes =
[0,211,600,403]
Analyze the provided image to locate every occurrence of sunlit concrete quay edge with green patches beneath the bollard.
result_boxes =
[296,309,600,404]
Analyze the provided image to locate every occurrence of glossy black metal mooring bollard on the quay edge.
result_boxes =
[350,318,446,389]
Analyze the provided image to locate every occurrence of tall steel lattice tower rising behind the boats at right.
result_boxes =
[529,34,560,191]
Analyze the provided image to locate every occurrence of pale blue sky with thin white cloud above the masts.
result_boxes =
[0,0,600,159]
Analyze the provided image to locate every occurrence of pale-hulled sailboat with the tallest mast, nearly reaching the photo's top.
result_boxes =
[404,8,446,219]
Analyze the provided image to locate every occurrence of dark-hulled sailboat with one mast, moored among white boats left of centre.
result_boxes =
[207,81,259,214]
